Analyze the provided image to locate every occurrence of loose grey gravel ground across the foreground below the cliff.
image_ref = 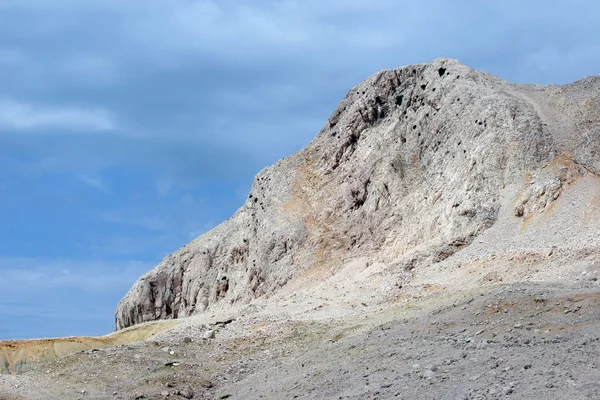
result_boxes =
[0,284,600,400]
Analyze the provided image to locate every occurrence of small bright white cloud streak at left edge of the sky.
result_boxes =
[0,100,115,131]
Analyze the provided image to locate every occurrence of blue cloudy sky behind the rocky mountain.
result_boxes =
[0,0,600,339]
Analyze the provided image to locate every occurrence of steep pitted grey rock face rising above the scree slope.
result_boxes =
[116,59,600,329]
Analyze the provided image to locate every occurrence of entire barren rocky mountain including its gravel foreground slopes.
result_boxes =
[0,59,600,400]
